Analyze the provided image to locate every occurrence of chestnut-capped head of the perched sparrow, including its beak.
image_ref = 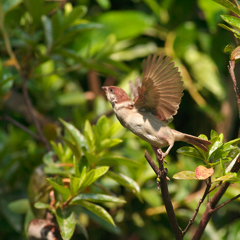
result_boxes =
[102,86,132,106]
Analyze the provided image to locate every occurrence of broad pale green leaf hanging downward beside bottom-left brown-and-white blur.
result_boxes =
[56,208,76,240]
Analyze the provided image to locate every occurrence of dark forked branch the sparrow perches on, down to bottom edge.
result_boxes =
[145,150,183,240]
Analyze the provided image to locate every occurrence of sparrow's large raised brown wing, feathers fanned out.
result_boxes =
[134,53,183,122]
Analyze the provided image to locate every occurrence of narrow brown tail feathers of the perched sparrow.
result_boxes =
[174,130,211,152]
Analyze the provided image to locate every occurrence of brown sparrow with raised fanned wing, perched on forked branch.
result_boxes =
[102,53,211,159]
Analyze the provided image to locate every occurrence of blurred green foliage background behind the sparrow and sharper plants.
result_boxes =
[0,0,240,240]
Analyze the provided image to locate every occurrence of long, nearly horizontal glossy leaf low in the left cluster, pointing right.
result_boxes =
[70,193,126,204]
